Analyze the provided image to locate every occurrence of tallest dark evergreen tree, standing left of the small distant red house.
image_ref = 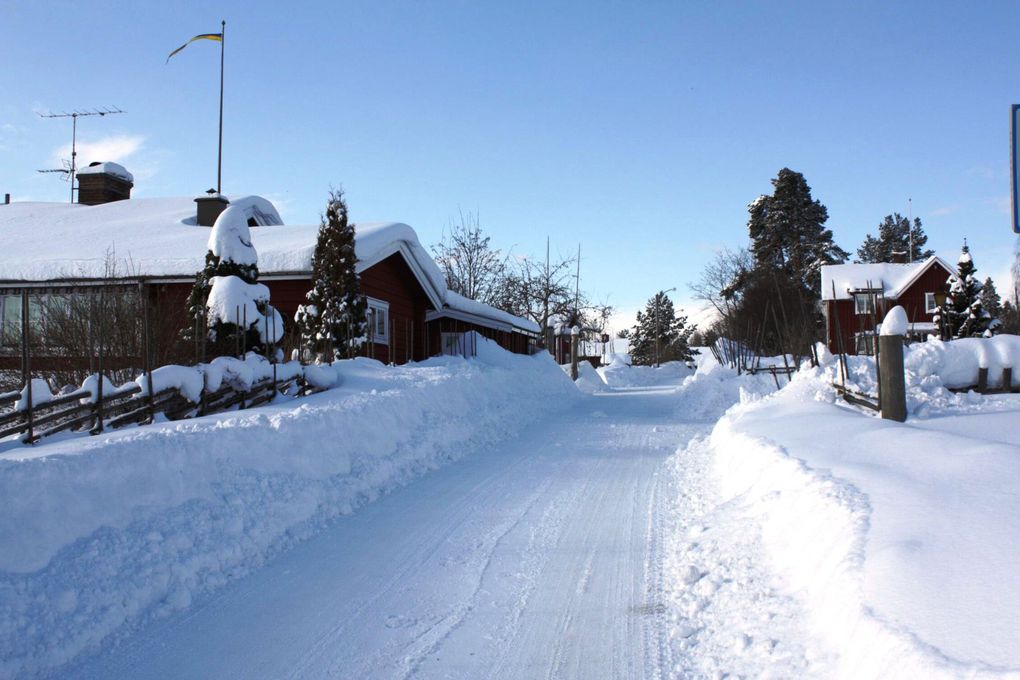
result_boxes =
[748,167,848,300]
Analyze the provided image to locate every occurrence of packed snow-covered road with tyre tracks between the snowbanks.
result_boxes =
[73,387,709,678]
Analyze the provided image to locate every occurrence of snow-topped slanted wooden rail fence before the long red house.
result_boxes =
[0,352,322,443]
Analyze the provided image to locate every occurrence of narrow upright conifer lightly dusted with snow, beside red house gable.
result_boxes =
[294,191,368,361]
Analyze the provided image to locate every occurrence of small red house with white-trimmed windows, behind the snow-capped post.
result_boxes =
[821,256,956,354]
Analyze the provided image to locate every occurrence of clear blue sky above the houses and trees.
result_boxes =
[0,0,1020,326]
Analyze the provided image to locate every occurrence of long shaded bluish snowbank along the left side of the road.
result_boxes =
[0,339,578,677]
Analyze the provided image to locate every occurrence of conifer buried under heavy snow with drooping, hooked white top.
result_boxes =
[185,206,284,357]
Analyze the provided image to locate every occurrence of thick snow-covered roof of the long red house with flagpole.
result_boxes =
[0,195,539,332]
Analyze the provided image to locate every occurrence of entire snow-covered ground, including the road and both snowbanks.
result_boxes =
[0,338,1020,678]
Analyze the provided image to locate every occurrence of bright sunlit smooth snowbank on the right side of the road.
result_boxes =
[711,360,1020,678]
